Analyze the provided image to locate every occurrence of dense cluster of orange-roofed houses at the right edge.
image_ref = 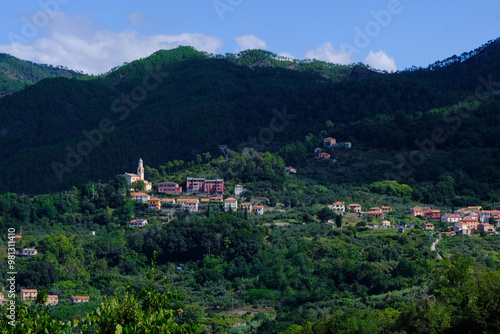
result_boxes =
[410,206,500,235]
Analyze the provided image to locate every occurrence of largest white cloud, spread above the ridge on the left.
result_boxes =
[0,12,222,74]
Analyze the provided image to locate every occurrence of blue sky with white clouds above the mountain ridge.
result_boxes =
[0,0,500,74]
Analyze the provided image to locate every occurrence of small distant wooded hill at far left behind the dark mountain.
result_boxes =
[0,53,82,97]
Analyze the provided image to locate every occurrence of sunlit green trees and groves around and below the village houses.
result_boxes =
[0,151,500,333]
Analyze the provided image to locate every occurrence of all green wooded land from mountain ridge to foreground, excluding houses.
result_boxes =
[0,40,500,334]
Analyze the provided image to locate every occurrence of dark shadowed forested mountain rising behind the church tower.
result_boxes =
[0,42,500,193]
